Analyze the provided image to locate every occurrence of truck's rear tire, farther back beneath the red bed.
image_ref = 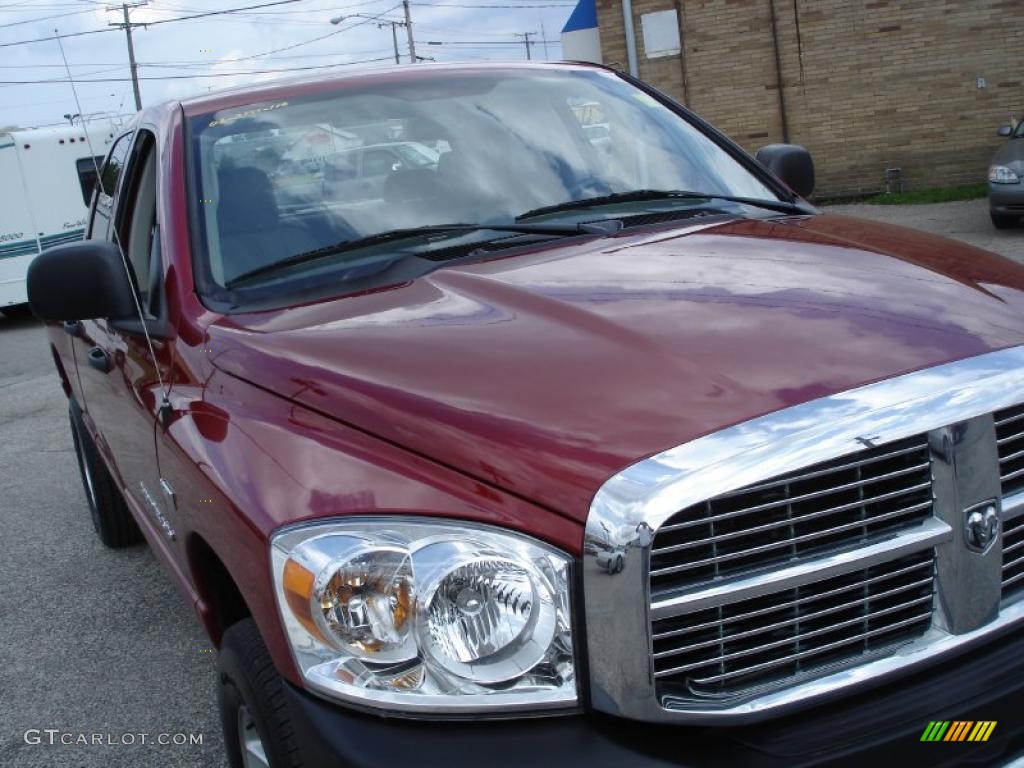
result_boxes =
[69,400,142,549]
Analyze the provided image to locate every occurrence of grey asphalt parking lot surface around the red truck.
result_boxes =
[0,201,1024,766]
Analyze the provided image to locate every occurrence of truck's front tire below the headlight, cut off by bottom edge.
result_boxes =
[217,618,302,768]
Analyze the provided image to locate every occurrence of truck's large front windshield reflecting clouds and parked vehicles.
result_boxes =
[189,69,778,301]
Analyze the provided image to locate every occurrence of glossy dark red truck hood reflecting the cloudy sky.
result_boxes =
[203,215,1024,520]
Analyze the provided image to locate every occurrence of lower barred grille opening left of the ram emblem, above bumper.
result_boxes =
[652,550,934,697]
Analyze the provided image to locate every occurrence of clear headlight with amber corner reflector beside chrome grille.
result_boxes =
[270,517,577,715]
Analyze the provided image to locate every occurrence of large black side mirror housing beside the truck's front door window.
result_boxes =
[27,240,135,322]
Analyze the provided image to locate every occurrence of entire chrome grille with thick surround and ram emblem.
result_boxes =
[582,352,1024,724]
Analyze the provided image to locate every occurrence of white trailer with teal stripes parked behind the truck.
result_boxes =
[0,119,119,311]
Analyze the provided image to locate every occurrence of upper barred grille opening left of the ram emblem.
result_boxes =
[650,435,932,595]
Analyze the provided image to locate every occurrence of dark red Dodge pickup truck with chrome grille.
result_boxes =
[29,65,1024,767]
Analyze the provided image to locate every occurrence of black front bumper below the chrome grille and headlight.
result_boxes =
[286,629,1024,768]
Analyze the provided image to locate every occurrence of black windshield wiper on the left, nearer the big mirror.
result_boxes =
[224,222,606,288]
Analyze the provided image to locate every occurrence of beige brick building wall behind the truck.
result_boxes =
[597,0,1024,197]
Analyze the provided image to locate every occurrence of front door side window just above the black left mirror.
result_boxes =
[114,130,163,315]
